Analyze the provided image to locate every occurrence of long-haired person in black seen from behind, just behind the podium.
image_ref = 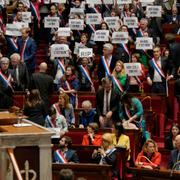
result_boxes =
[24,89,47,126]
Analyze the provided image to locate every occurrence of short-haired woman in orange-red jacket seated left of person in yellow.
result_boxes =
[82,123,102,146]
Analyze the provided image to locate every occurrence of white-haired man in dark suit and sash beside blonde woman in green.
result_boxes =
[98,43,116,84]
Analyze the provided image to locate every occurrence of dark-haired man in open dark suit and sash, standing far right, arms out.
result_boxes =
[147,46,175,93]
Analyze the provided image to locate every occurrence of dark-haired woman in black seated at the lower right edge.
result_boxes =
[165,123,180,150]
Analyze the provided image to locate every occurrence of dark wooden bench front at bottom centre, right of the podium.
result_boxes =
[52,163,112,180]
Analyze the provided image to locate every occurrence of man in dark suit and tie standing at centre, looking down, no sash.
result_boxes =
[96,77,120,128]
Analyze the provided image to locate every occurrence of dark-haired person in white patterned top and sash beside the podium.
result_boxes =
[45,107,68,138]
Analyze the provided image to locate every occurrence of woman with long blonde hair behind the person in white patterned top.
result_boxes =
[53,92,75,127]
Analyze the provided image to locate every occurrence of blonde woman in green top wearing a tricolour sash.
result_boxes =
[112,60,127,92]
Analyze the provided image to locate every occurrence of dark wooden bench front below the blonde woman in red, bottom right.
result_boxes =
[129,168,180,180]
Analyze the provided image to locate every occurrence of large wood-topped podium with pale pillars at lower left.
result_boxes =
[0,119,53,180]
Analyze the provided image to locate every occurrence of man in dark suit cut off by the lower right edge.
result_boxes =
[168,135,180,170]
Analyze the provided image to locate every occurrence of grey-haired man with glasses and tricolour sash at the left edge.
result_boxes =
[0,57,14,109]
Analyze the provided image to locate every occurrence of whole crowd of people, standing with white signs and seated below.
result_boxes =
[0,0,180,179]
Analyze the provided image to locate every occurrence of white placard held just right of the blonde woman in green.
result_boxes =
[124,63,142,76]
